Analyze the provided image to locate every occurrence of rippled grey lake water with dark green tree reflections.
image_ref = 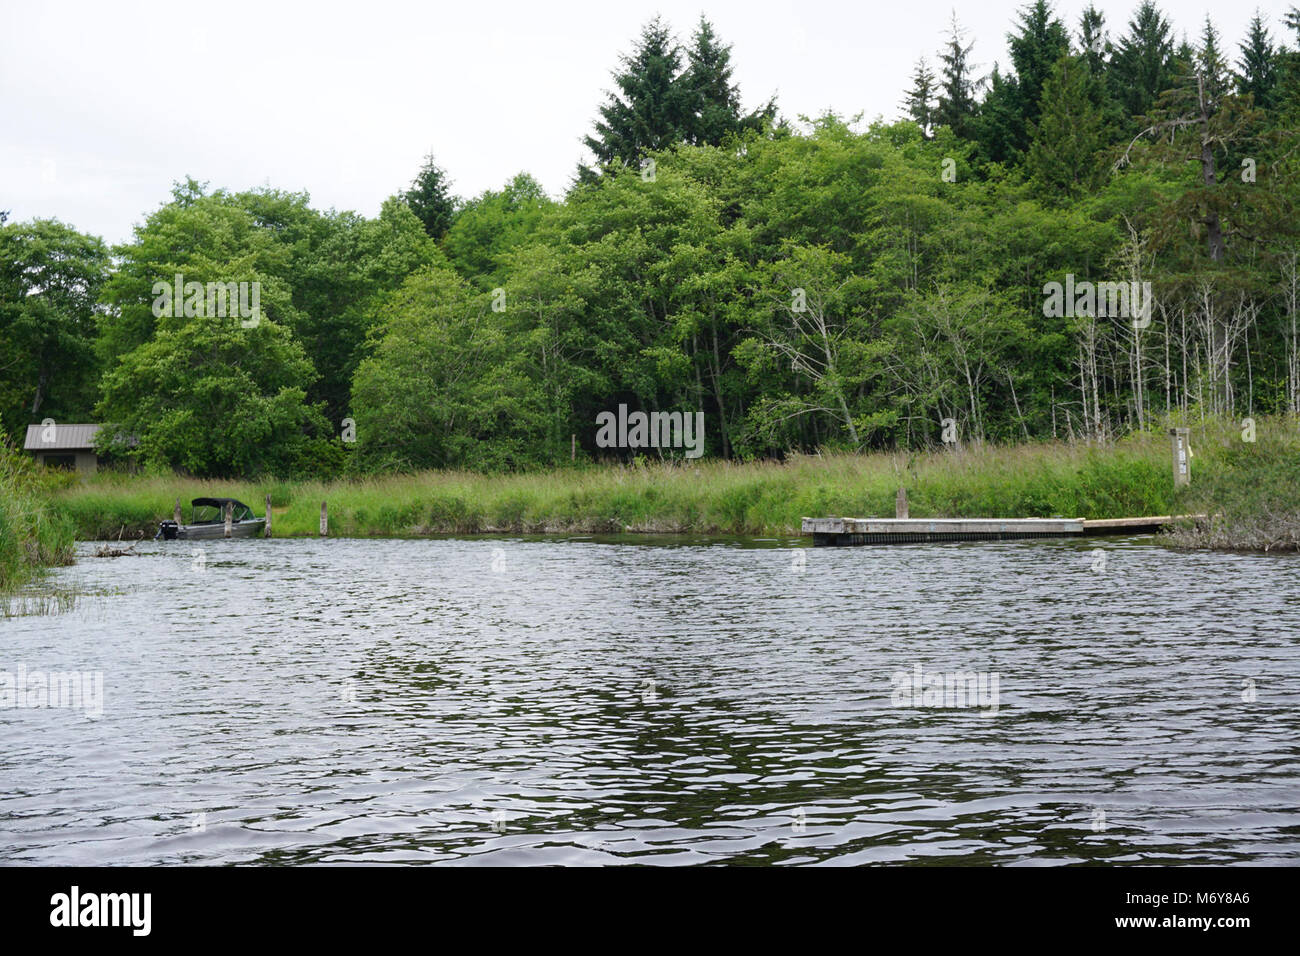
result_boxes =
[0,537,1300,865]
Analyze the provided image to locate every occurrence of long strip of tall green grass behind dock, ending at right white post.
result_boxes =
[56,437,1173,538]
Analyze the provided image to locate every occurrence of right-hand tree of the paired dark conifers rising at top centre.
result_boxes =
[677,17,776,146]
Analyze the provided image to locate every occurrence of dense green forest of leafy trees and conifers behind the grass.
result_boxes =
[0,0,1300,477]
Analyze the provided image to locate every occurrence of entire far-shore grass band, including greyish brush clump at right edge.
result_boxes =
[40,419,1300,550]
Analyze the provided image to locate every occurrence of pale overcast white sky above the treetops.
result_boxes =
[0,0,1300,242]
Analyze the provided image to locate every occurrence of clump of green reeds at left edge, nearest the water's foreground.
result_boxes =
[0,441,74,592]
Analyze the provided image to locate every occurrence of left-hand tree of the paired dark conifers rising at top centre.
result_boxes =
[579,17,691,181]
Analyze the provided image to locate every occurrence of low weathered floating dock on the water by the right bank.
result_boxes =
[803,515,1178,545]
